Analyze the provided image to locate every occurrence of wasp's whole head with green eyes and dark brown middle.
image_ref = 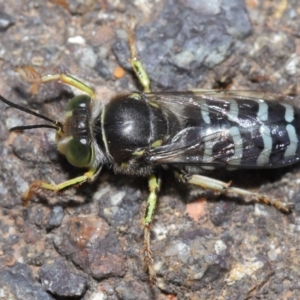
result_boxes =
[56,95,93,168]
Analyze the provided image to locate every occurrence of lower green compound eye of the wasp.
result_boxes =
[65,138,92,168]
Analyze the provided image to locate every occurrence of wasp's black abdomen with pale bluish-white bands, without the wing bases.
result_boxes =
[188,99,300,168]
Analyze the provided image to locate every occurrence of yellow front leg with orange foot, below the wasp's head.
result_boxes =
[22,170,100,206]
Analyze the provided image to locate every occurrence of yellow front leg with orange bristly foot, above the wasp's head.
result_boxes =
[15,66,95,99]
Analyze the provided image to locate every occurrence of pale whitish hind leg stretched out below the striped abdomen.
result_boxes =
[181,175,290,212]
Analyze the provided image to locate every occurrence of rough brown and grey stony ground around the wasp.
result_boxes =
[0,0,300,300]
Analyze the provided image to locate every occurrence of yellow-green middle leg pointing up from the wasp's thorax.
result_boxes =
[128,17,150,93]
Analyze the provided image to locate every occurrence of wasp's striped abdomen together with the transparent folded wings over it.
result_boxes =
[148,93,300,169]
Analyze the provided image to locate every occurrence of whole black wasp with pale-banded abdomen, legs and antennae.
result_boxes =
[0,22,300,282]
